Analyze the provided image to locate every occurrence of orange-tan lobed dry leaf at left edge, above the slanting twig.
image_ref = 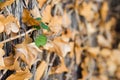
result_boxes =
[0,15,20,35]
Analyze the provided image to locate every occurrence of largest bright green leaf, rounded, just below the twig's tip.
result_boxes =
[35,34,47,47]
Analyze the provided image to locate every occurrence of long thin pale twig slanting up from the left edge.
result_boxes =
[0,28,36,44]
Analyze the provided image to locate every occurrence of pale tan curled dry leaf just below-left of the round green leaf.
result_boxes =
[15,35,42,68]
